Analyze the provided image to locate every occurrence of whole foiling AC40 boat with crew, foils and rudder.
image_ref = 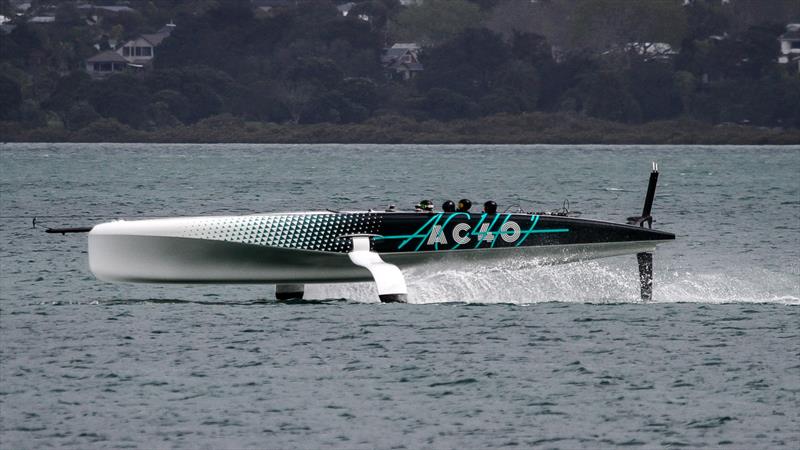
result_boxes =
[48,165,675,301]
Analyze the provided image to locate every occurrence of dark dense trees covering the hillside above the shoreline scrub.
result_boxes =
[0,0,800,140]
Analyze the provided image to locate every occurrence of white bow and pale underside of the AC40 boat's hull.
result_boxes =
[89,218,663,284]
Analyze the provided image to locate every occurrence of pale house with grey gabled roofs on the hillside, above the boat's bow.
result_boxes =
[86,22,175,77]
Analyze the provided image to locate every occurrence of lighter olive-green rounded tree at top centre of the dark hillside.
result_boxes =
[389,0,482,46]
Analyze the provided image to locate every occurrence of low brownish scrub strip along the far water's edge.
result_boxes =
[0,113,800,145]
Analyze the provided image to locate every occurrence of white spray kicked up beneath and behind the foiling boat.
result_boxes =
[306,258,800,305]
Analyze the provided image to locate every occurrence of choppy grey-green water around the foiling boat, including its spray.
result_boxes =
[0,144,800,448]
